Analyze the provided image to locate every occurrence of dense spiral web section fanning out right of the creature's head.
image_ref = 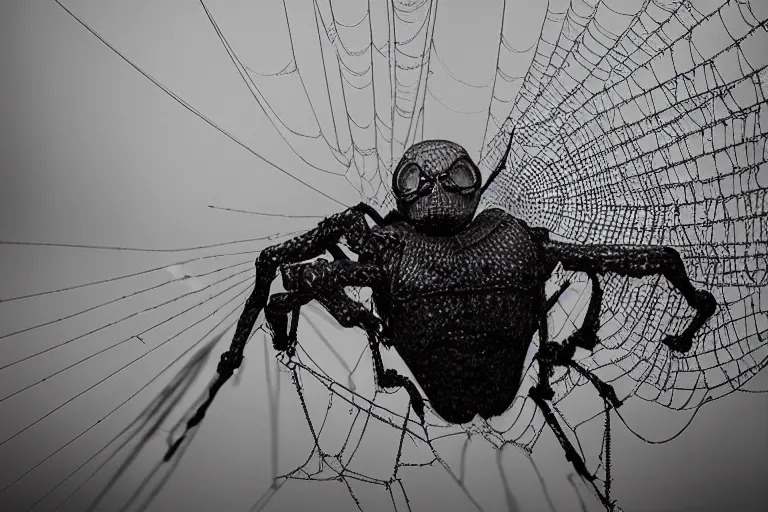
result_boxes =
[486,2,768,418]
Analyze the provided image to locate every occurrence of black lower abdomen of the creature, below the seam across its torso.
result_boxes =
[390,289,536,423]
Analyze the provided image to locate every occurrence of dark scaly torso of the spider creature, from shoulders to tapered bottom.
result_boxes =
[370,209,548,423]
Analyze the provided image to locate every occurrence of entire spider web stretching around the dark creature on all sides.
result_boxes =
[0,0,768,510]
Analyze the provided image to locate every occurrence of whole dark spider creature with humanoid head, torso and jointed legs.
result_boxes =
[166,134,716,508]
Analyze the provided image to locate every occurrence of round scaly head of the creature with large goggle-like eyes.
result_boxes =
[392,140,481,235]
